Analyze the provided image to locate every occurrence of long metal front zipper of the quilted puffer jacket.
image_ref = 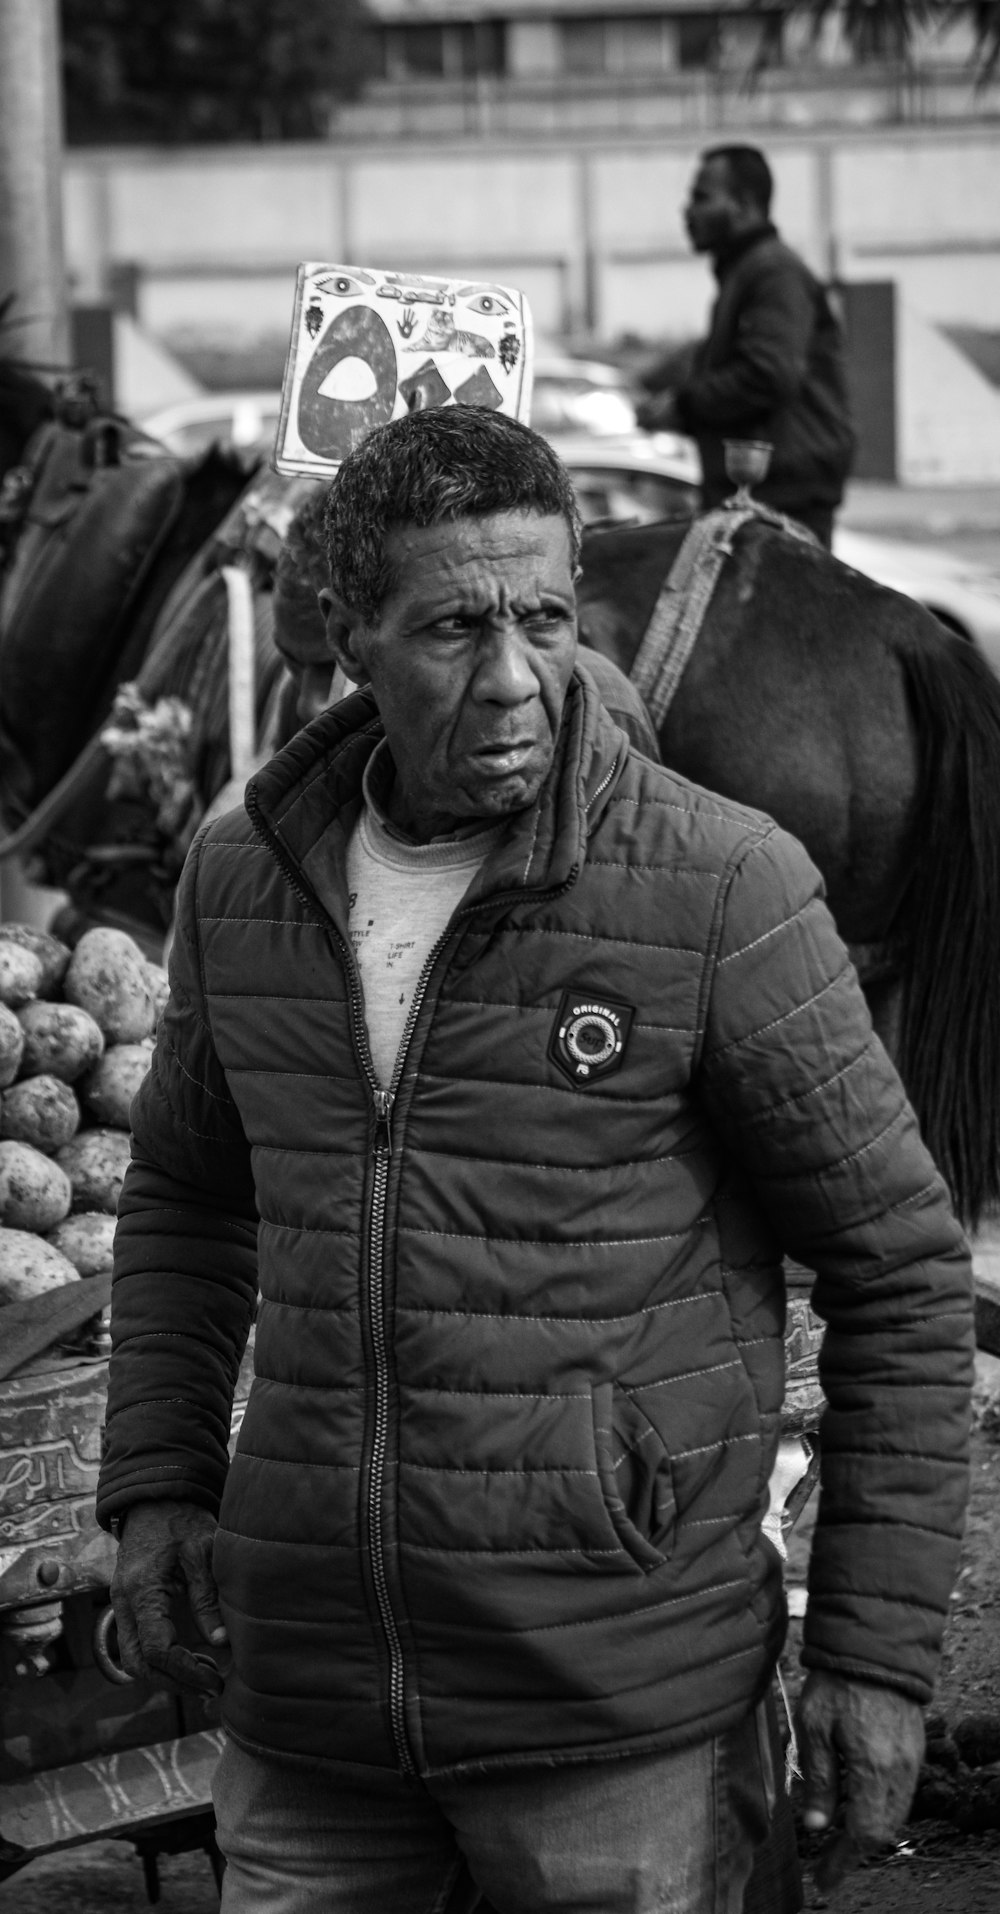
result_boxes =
[245,780,593,1776]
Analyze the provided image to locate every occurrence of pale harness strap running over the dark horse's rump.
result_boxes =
[628,498,816,731]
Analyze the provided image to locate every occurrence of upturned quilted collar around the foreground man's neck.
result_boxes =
[245,670,628,915]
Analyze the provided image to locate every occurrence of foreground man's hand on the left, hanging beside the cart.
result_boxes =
[111,1502,228,1694]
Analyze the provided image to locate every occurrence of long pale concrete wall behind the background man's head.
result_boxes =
[65,124,1000,352]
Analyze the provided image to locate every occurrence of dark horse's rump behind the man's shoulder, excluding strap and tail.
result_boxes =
[579,519,915,944]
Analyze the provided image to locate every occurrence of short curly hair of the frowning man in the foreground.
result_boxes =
[326,406,582,622]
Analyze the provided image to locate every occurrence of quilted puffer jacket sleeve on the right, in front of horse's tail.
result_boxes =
[701,831,973,1702]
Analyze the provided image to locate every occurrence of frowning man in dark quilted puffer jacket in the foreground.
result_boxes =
[98,408,971,1914]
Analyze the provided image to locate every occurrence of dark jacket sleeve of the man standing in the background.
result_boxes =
[676,258,816,431]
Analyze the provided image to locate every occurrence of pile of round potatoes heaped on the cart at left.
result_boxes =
[0,924,167,1305]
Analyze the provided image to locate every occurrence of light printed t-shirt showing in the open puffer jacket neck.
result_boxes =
[347,802,504,1089]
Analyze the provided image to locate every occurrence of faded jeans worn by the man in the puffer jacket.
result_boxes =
[215,1705,780,1914]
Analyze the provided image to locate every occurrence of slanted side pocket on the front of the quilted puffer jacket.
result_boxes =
[592,1382,676,1569]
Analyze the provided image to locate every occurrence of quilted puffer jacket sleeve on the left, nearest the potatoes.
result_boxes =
[98,838,257,1527]
